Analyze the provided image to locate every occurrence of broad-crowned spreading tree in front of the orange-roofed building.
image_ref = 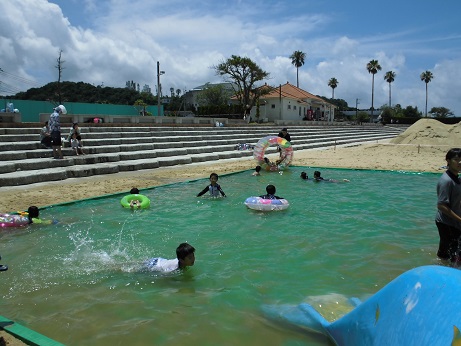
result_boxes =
[213,55,269,112]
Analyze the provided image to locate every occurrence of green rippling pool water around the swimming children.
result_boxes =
[0,167,439,346]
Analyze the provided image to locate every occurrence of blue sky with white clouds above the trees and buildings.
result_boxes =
[0,0,461,116]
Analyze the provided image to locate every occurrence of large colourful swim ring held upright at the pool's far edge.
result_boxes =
[253,136,293,171]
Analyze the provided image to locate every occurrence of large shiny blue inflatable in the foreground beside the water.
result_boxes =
[263,265,461,346]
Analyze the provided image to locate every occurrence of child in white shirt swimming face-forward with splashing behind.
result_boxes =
[144,243,195,273]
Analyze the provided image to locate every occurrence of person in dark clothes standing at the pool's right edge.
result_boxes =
[435,148,461,264]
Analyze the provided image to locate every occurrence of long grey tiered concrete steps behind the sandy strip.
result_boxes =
[0,125,404,186]
